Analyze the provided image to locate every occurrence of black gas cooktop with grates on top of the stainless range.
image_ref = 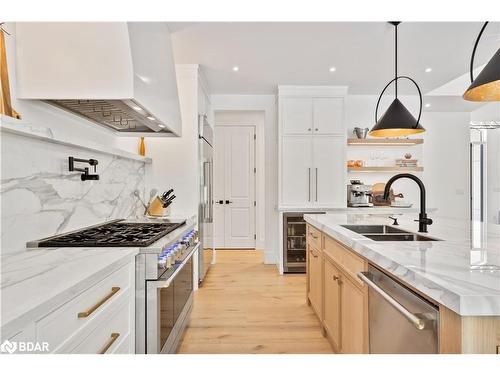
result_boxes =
[28,220,186,247]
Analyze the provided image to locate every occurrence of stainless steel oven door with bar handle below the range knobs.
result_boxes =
[145,246,198,354]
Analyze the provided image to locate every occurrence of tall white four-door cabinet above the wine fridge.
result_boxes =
[278,86,347,209]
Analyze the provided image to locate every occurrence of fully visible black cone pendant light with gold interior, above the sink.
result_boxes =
[369,22,425,138]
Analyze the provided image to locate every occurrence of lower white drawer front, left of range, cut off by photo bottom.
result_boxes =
[72,298,134,354]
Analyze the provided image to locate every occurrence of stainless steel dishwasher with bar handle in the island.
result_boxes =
[358,266,439,354]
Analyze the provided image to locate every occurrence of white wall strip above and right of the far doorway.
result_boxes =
[211,95,278,264]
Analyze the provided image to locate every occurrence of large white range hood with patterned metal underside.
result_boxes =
[16,22,181,136]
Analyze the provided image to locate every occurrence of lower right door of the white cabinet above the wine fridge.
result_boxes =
[311,136,347,207]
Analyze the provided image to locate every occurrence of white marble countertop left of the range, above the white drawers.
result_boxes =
[0,247,139,338]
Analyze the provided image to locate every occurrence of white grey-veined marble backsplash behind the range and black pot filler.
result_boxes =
[0,132,146,254]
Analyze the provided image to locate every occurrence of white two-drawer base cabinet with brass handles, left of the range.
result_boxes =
[35,258,135,354]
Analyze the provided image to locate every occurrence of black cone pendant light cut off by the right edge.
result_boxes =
[463,22,500,102]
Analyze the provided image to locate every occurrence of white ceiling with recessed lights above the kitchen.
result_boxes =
[168,22,500,108]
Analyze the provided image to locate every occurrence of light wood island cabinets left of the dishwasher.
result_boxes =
[307,225,368,354]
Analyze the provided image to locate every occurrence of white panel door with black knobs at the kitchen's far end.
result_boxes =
[215,126,255,248]
